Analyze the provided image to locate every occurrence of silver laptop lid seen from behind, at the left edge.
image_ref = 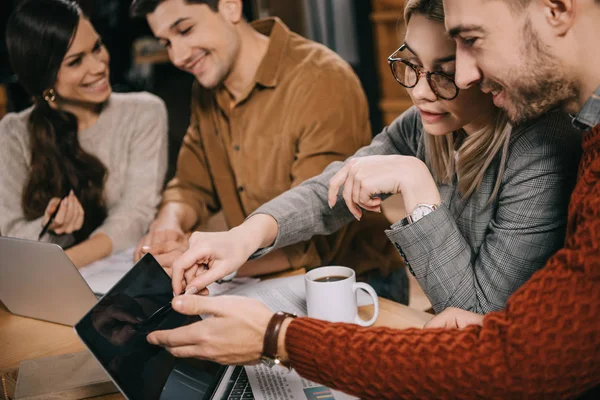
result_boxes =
[0,237,97,326]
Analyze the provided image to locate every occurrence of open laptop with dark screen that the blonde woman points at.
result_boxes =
[74,254,254,400]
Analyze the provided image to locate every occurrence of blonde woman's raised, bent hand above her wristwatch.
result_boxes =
[328,155,440,220]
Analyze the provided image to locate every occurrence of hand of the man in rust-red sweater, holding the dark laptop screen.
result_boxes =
[148,296,273,365]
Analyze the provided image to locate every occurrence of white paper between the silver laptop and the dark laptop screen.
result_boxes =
[79,247,135,295]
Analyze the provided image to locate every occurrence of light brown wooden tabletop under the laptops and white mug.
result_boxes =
[0,298,433,400]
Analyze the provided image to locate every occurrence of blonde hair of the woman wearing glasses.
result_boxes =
[404,0,512,204]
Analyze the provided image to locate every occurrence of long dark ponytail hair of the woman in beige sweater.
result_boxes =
[6,0,107,241]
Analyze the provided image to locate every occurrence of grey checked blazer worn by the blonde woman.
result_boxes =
[254,107,581,313]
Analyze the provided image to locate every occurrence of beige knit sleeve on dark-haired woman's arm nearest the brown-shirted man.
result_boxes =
[90,97,168,252]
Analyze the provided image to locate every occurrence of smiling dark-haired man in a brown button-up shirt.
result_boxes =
[132,0,401,288]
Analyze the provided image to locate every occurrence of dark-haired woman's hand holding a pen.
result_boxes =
[42,190,85,235]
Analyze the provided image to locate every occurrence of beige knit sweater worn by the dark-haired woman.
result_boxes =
[0,93,167,251]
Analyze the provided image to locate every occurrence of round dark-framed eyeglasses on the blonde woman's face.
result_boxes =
[388,44,459,100]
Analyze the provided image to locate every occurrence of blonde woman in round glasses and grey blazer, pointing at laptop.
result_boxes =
[165,0,580,314]
